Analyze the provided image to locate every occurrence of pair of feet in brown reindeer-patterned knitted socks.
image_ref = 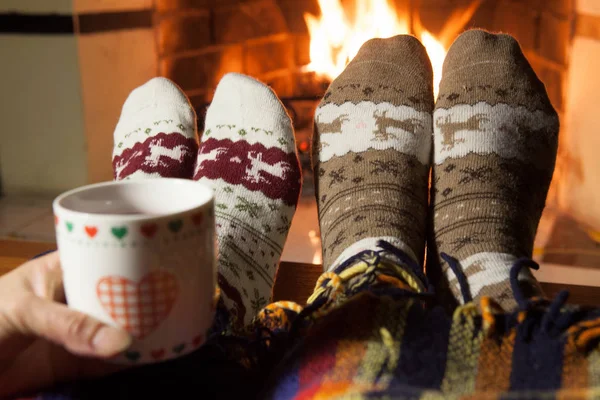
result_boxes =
[313,30,559,309]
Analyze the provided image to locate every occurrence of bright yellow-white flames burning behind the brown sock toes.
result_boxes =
[304,0,482,96]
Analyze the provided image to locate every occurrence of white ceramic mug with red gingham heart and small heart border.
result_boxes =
[53,178,217,364]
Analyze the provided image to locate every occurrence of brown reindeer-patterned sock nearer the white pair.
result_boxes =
[313,36,433,270]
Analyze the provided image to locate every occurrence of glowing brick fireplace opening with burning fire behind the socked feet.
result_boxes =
[155,0,576,263]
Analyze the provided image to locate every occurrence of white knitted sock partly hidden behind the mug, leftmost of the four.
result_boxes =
[112,78,198,180]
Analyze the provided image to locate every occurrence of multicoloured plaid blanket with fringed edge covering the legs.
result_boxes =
[41,242,600,399]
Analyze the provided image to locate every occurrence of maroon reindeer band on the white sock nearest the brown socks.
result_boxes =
[194,138,300,206]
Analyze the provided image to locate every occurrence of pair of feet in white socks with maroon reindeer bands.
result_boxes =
[113,74,301,329]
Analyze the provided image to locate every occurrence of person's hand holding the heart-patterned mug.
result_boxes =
[0,252,131,398]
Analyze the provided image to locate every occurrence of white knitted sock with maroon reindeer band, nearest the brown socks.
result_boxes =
[194,73,301,328]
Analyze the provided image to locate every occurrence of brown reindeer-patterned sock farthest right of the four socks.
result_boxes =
[428,30,559,308]
